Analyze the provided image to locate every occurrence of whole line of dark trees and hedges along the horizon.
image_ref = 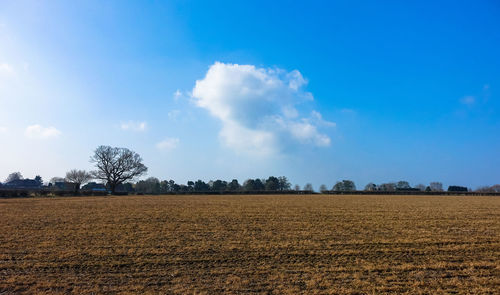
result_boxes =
[0,146,500,194]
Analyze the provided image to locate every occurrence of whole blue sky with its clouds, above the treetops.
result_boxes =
[0,1,500,188]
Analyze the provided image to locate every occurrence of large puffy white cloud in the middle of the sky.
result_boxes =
[192,62,334,154]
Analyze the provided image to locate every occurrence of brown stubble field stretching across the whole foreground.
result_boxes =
[0,195,500,294]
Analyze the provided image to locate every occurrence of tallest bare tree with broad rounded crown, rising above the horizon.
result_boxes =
[90,145,148,194]
